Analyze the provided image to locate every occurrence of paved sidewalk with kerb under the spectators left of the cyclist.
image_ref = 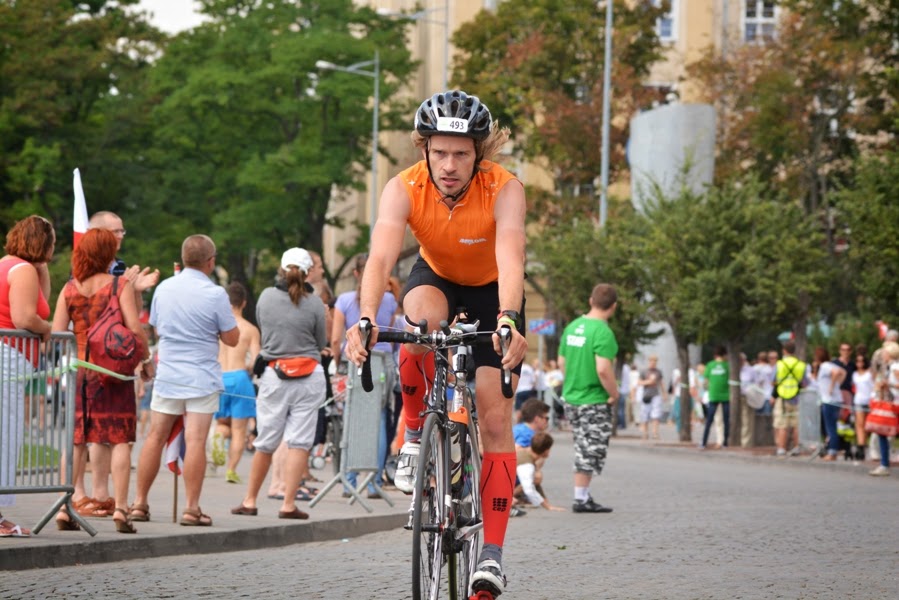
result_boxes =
[0,447,409,571]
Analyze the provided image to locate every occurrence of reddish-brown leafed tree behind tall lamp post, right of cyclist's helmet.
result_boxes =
[453,0,667,202]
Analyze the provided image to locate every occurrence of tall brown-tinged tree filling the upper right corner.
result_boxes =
[689,0,899,355]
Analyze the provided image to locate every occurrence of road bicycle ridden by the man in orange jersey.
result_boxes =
[360,311,512,600]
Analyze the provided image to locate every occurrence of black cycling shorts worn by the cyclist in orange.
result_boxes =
[403,255,525,375]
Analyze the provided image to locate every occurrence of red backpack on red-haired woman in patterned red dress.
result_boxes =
[85,277,143,384]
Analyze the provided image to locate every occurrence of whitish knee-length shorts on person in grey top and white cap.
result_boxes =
[253,366,325,454]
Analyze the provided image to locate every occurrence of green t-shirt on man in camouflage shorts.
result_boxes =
[559,317,618,406]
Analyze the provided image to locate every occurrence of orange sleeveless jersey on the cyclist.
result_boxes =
[398,160,515,286]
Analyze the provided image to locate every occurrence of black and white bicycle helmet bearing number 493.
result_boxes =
[415,90,493,140]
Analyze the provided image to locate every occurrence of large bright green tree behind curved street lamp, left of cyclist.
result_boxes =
[138,0,415,296]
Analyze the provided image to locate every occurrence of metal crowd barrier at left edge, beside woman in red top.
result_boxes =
[0,329,97,536]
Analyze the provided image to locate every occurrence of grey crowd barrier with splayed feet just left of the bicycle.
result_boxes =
[309,352,393,512]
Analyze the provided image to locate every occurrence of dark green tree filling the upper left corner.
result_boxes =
[0,0,163,289]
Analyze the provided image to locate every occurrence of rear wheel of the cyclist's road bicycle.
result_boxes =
[447,418,484,600]
